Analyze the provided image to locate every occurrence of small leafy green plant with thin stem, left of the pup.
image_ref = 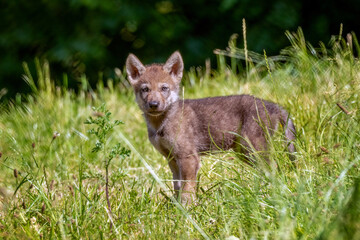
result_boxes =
[85,104,130,218]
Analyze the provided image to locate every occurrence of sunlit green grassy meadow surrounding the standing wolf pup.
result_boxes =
[0,30,360,240]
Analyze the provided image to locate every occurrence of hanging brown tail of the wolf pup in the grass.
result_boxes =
[280,110,296,161]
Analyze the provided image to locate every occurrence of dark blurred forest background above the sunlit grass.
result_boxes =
[0,0,360,99]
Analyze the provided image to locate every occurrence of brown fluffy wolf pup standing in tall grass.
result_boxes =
[126,52,295,202]
